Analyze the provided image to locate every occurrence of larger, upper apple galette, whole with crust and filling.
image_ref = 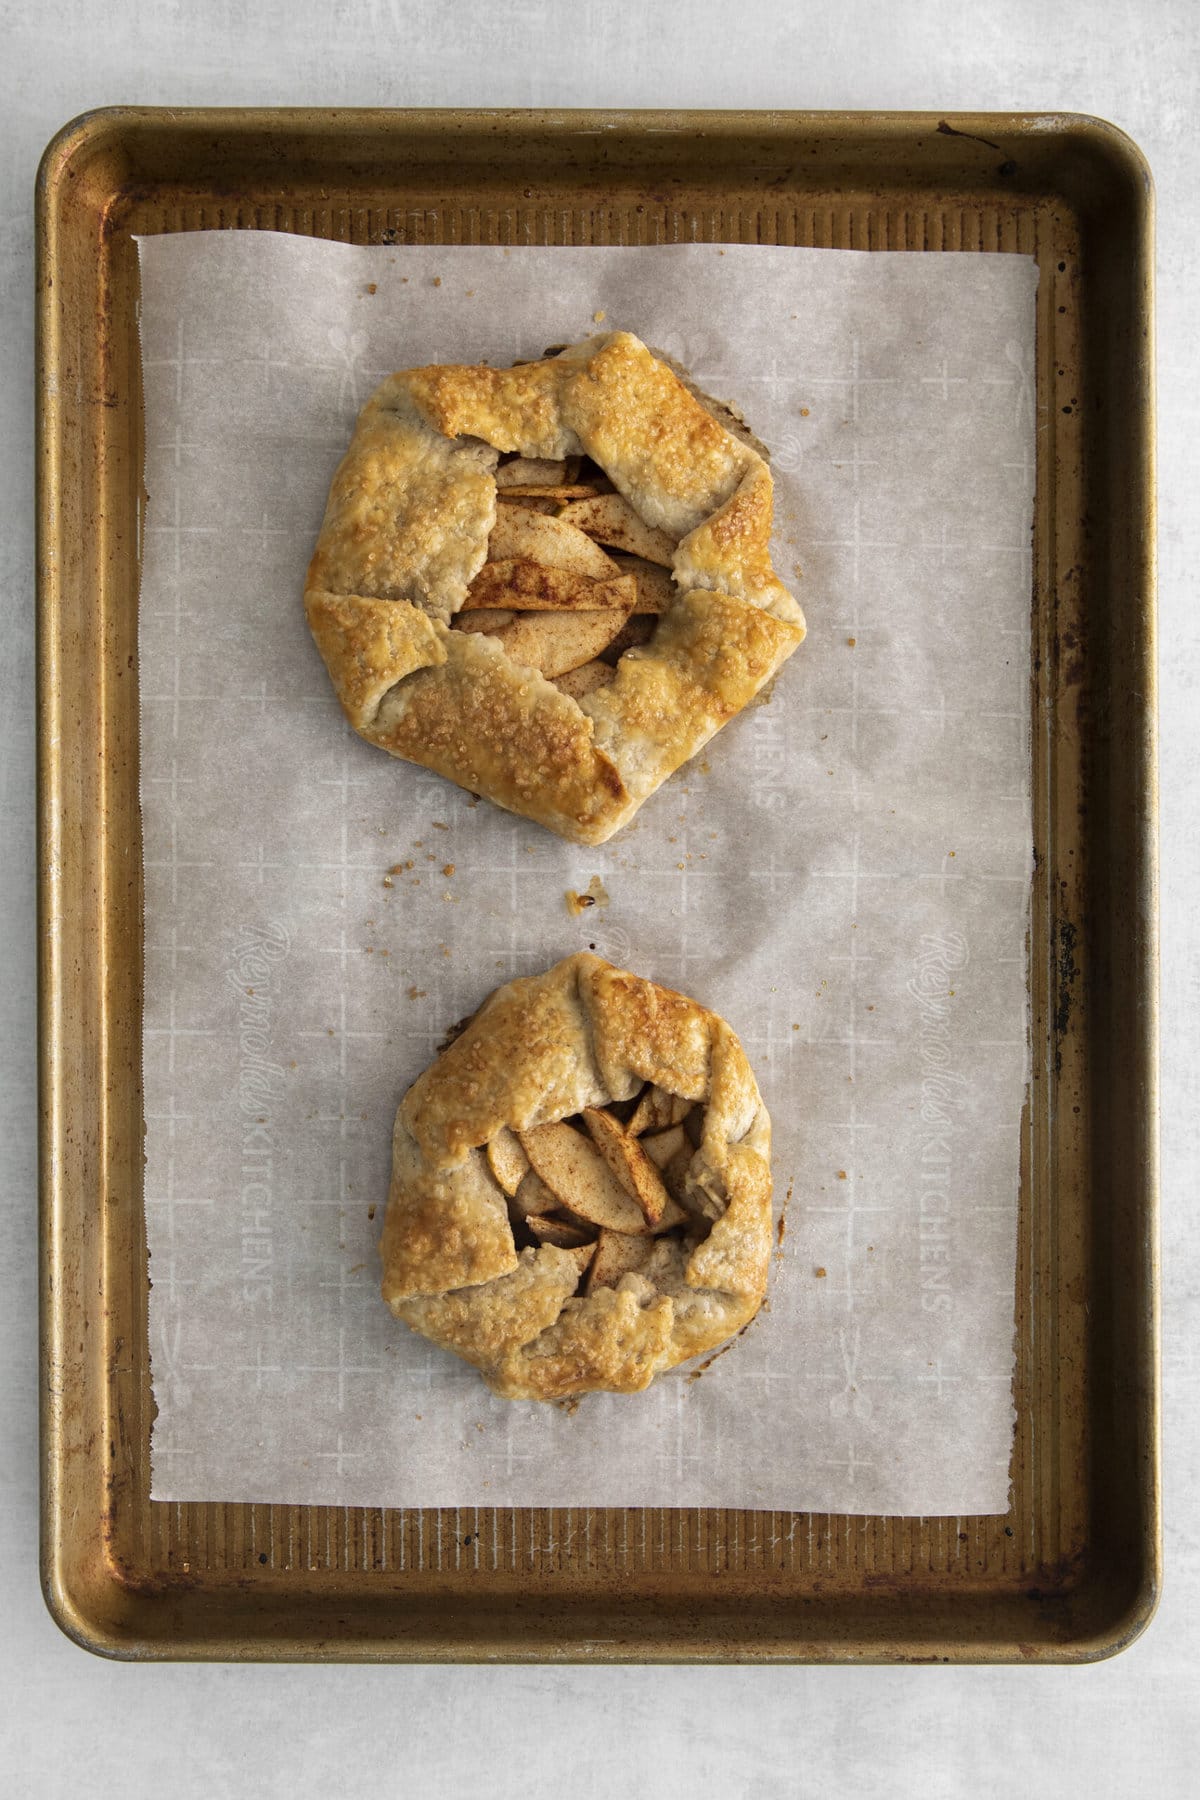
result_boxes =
[304,331,804,844]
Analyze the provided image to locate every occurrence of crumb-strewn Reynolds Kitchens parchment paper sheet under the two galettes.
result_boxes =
[140,232,1036,1514]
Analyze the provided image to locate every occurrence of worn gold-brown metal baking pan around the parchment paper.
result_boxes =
[38,110,1160,1661]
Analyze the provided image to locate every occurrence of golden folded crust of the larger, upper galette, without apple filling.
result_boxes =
[304,331,804,844]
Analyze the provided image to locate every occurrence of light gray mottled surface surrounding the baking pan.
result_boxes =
[0,0,1200,1800]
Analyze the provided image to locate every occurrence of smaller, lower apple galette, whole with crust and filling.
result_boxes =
[380,952,772,1400]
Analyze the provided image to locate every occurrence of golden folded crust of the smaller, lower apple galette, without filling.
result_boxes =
[380,952,772,1400]
